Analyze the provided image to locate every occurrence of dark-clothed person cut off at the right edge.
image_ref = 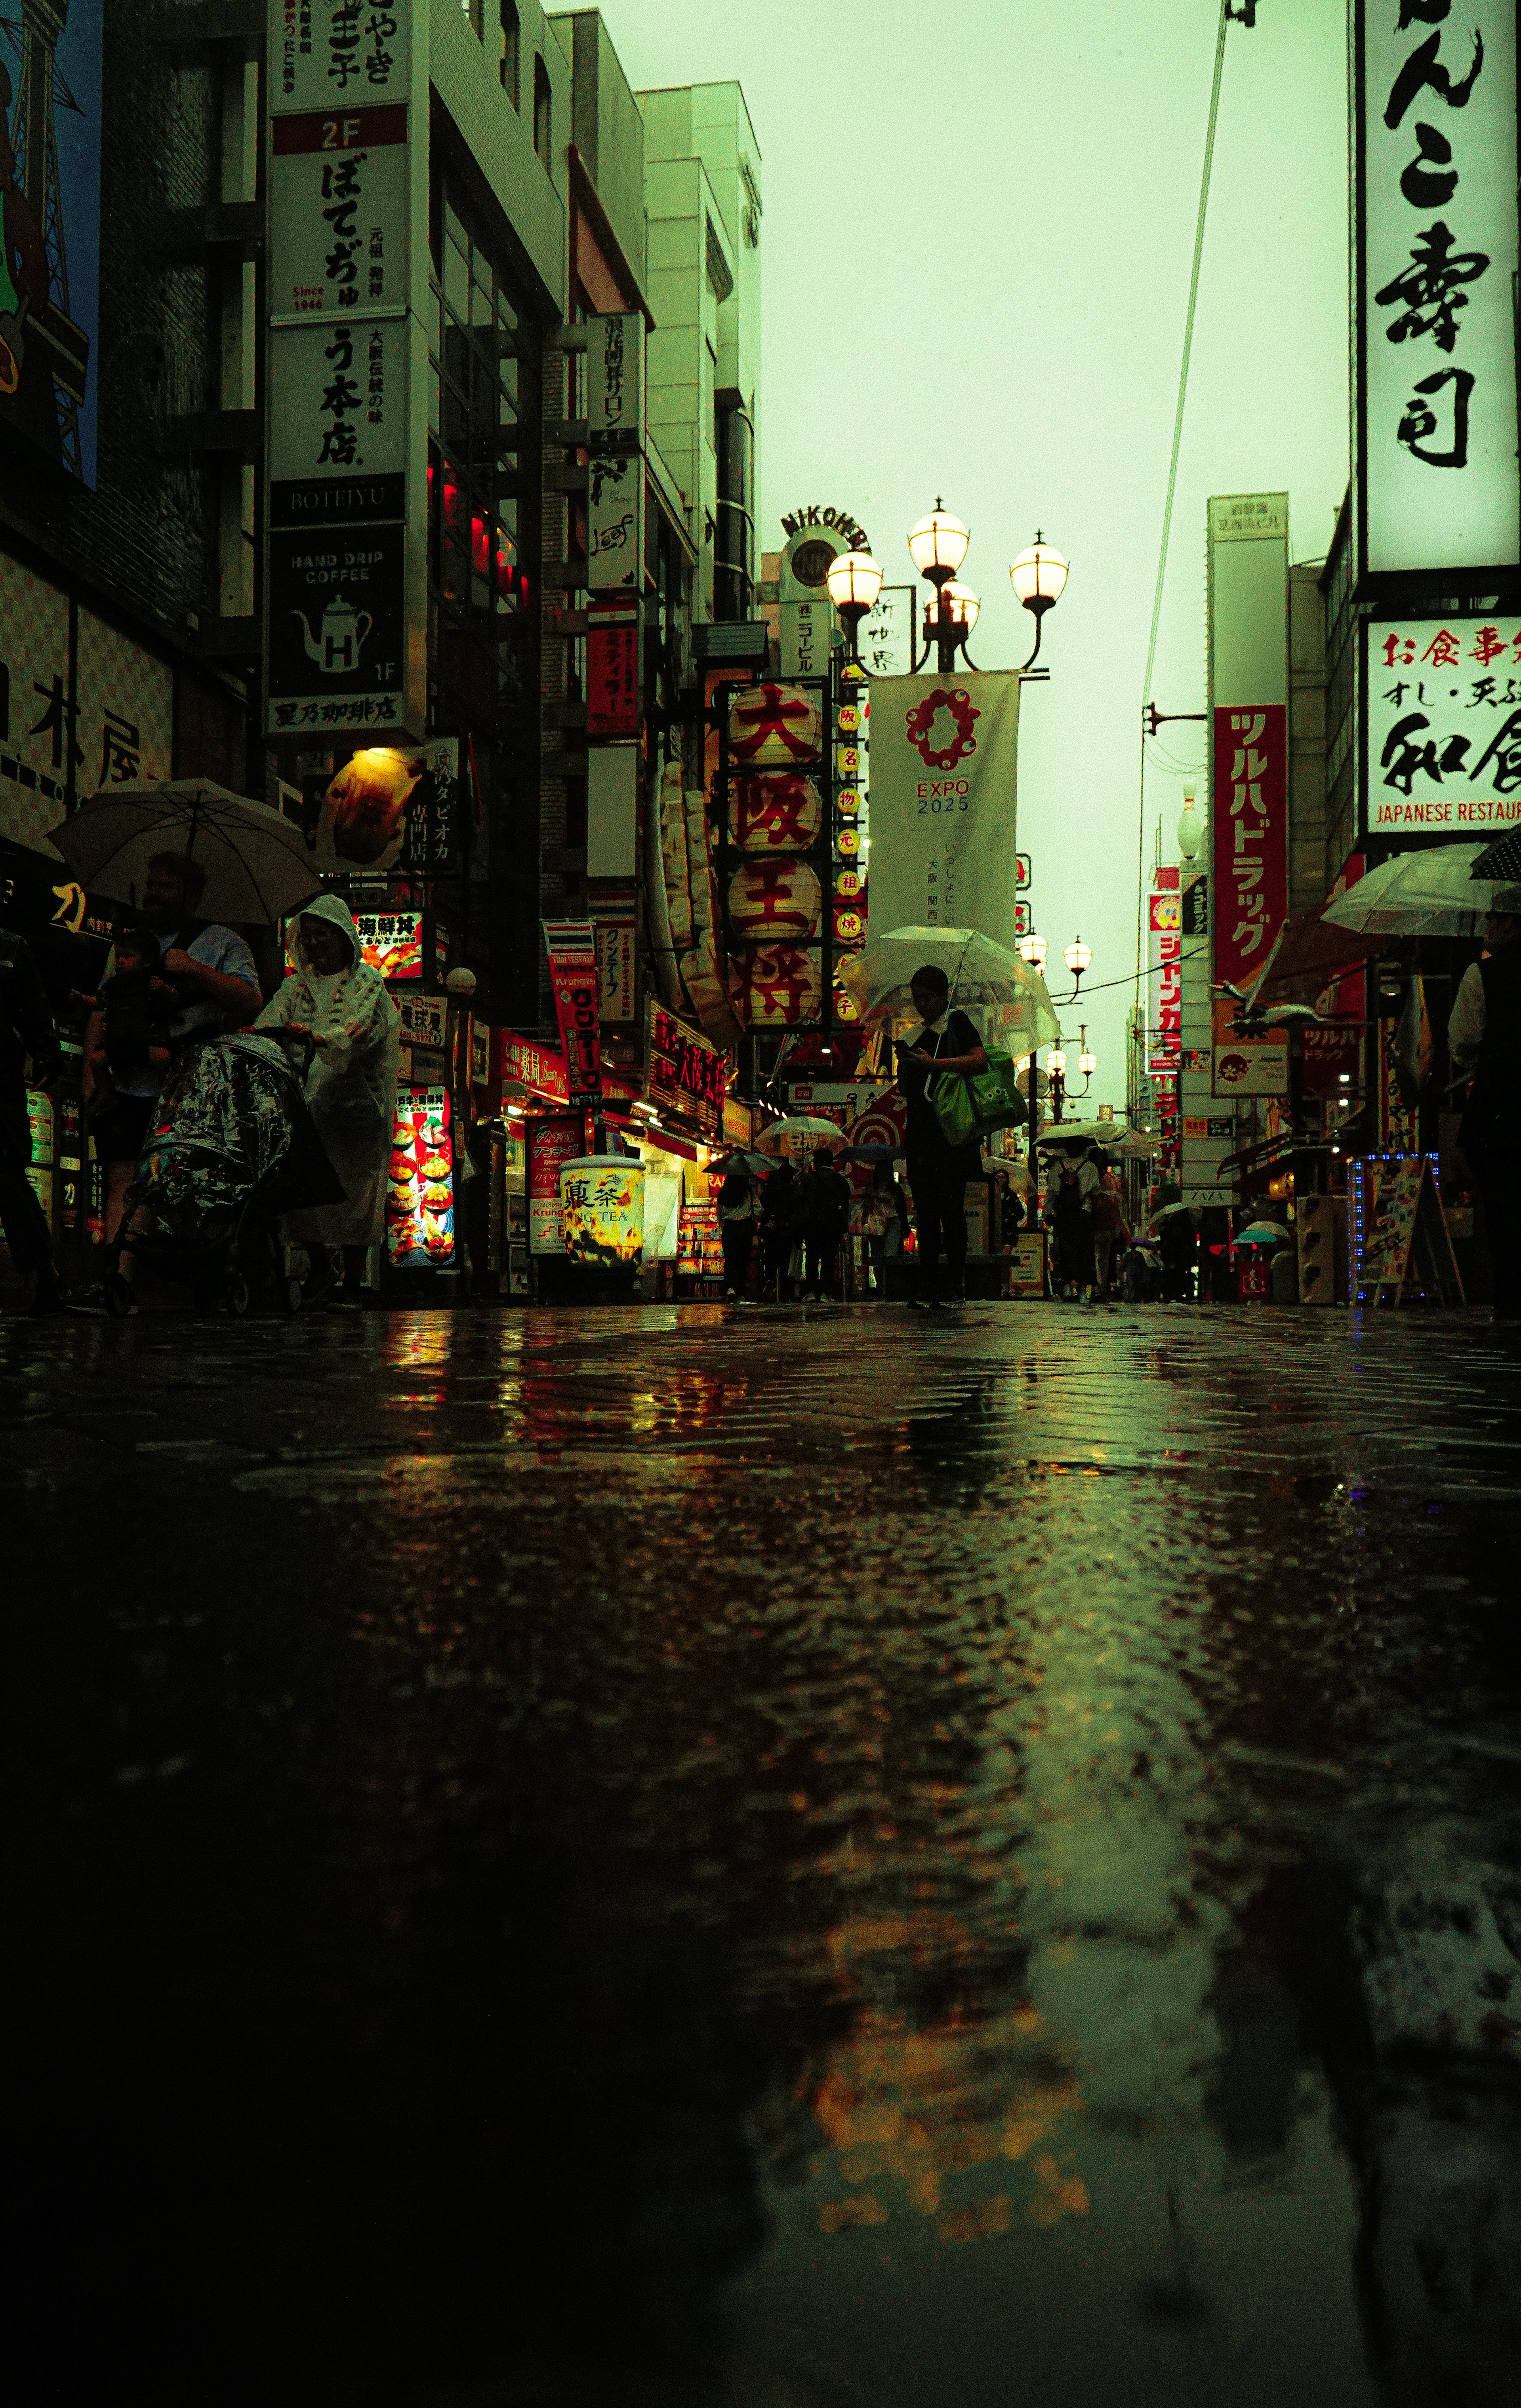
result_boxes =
[1446,910,1521,1322]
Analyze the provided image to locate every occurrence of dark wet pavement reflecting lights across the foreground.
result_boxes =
[0,1305,1521,2408]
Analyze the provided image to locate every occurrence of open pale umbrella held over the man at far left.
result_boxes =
[48,778,318,925]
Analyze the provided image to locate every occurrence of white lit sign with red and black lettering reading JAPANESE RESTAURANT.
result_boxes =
[1362,612,1521,838]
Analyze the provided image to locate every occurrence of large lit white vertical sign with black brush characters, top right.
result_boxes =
[1352,0,1521,573]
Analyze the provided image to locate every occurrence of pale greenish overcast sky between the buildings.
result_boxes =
[602,0,1348,1103]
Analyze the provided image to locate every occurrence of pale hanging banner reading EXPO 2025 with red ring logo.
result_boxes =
[868,670,1020,949]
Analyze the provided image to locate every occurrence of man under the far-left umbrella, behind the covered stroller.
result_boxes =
[84,853,260,1245]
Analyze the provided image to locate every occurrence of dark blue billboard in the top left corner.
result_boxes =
[0,0,104,486]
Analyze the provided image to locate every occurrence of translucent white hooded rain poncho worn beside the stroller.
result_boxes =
[253,896,400,1245]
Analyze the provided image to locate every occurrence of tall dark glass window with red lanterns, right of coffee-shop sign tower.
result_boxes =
[427,182,540,770]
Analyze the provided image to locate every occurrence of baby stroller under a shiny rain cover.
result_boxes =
[101,1031,345,1317]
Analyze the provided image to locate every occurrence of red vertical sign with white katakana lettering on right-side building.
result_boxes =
[1212,703,1290,987]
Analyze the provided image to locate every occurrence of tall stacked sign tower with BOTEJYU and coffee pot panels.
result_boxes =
[265,0,427,737]
